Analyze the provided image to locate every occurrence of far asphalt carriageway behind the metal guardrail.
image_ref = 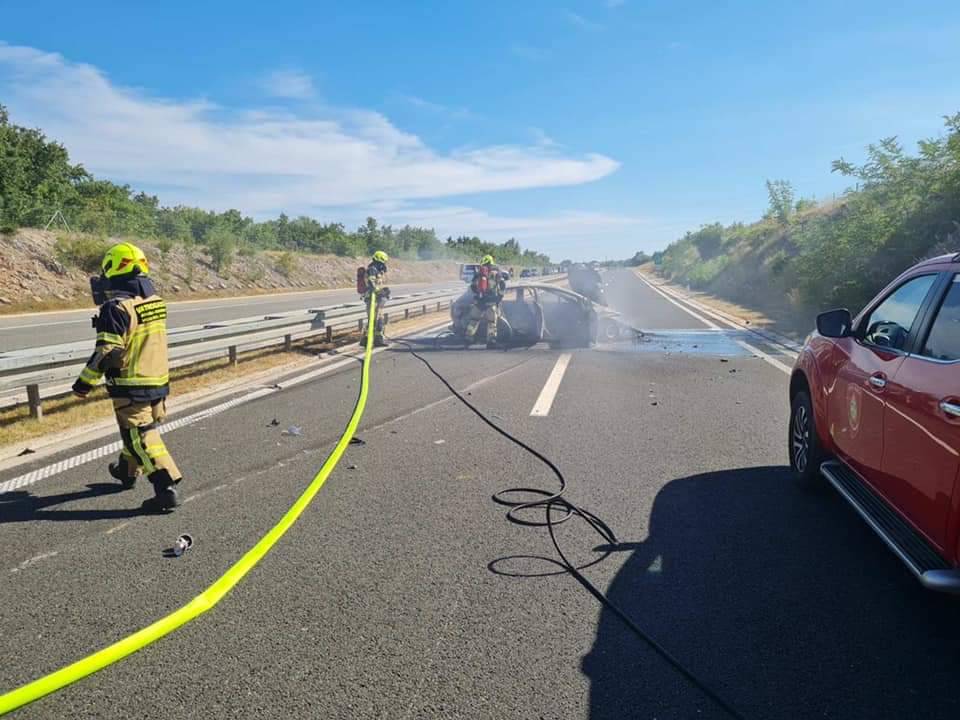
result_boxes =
[0,280,459,350]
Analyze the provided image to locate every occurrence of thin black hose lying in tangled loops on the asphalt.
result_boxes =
[393,340,744,720]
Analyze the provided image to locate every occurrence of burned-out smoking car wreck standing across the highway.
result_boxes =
[450,284,633,347]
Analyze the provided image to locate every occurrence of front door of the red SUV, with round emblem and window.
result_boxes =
[828,273,937,492]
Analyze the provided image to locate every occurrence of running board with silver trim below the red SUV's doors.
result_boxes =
[820,460,960,594]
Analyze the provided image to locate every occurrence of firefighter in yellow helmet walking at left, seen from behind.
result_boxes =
[73,243,181,511]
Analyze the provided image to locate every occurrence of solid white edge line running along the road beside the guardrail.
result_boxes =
[0,321,454,494]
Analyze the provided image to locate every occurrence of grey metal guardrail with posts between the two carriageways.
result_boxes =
[0,289,463,419]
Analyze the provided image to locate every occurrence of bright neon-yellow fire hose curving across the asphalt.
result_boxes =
[0,294,377,715]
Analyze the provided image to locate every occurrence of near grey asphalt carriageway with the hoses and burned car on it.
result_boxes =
[0,273,960,720]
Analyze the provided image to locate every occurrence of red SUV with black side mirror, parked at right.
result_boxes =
[789,254,960,593]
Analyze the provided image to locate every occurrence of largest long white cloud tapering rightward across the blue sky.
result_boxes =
[0,43,619,215]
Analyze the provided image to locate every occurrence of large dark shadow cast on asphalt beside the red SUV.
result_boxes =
[583,467,960,720]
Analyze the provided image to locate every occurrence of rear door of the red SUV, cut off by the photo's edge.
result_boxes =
[881,274,960,550]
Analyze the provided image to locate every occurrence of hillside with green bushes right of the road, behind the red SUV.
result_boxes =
[654,113,960,318]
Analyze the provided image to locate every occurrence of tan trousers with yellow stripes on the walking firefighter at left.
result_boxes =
[113,398,181,485]
